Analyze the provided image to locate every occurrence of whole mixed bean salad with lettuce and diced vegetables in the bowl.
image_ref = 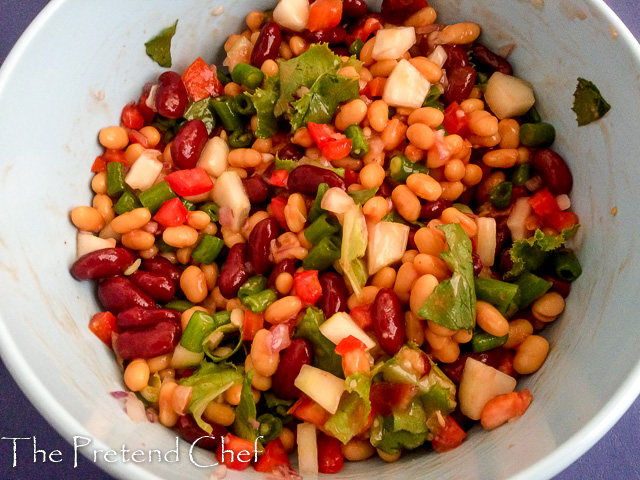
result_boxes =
[71,0,581,478]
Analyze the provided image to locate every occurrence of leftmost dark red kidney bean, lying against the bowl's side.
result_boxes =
[71,247,136,280]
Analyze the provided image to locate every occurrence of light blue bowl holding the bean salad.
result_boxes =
[0,0,640,479]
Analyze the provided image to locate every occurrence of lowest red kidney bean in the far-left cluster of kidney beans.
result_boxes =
[113,321,181,360]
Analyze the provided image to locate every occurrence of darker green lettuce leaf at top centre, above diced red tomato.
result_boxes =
[291,73,360,132]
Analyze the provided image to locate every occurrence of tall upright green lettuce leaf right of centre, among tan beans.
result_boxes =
[418,223,476,330]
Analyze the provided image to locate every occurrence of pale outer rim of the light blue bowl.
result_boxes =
[0,0,640,480]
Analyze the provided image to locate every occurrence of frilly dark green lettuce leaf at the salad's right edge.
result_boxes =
[504,225,579,280]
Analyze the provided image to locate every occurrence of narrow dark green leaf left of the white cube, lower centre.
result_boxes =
[293,307,344,378]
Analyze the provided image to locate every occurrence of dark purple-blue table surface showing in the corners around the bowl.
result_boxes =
[0,0,640,480]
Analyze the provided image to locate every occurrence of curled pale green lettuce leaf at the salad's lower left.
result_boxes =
[180,361,242,434]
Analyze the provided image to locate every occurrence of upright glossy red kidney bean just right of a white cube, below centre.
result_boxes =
[371,288,405,355]
